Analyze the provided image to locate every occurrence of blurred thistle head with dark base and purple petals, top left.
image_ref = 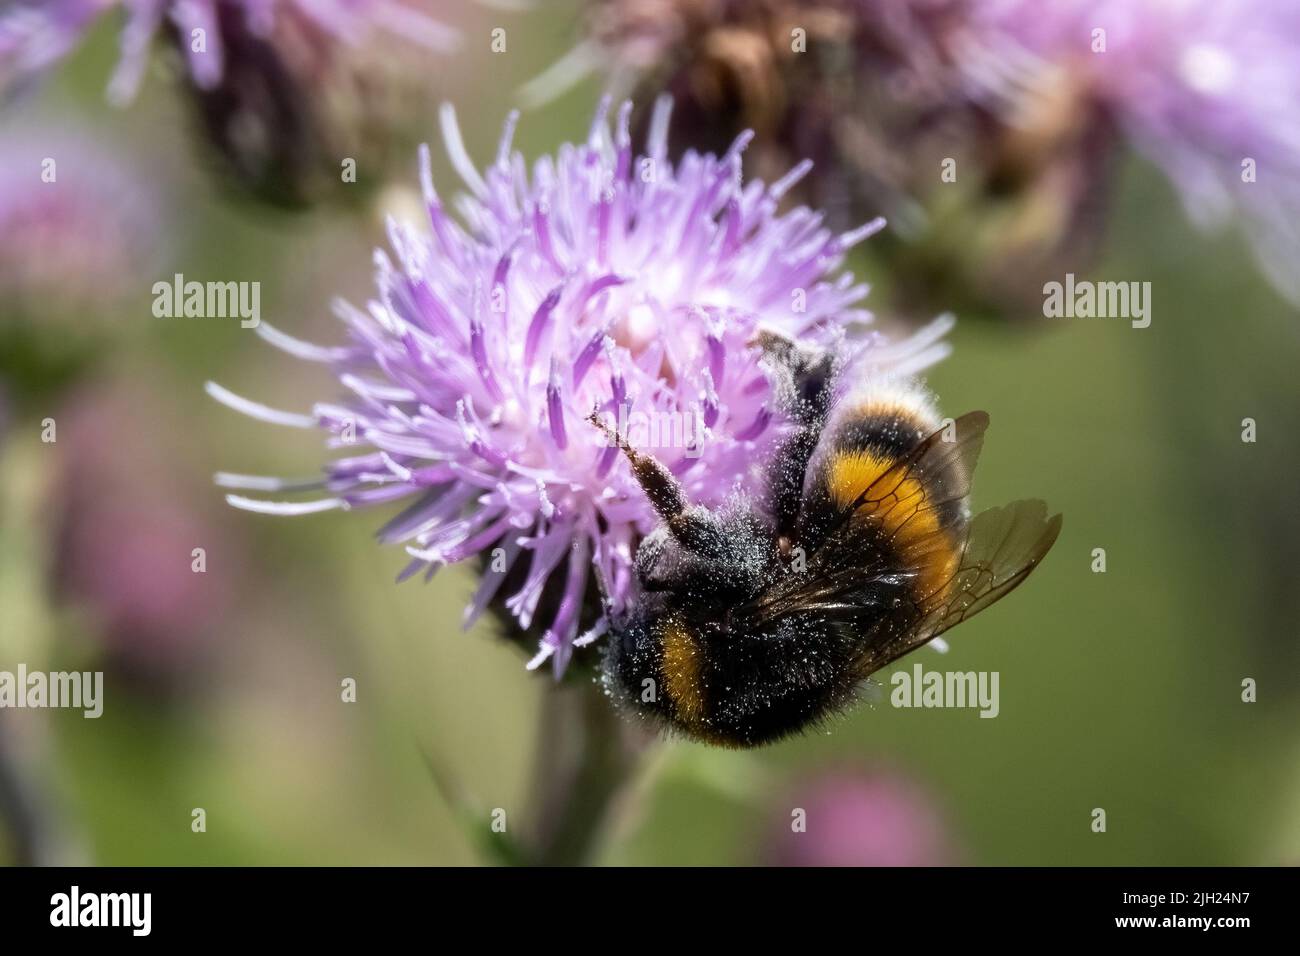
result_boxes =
[0,0,458,206]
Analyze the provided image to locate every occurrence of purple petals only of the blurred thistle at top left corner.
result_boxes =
[0,0,456,103]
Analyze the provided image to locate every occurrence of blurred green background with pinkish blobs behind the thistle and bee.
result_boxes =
[0,1,1300,865]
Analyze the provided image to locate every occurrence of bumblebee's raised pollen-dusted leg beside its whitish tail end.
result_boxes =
[751,332,836,538]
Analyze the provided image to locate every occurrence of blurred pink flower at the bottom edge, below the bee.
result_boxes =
[763,769,957,866]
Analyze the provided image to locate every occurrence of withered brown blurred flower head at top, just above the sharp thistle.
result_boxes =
[524,0,974,226]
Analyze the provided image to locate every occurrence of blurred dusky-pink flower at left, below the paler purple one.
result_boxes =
[51,382,238,678]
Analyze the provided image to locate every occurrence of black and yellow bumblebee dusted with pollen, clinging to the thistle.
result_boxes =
[592,334,1061,748]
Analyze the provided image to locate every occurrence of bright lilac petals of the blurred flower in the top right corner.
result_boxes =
[965,0,1300,300]
